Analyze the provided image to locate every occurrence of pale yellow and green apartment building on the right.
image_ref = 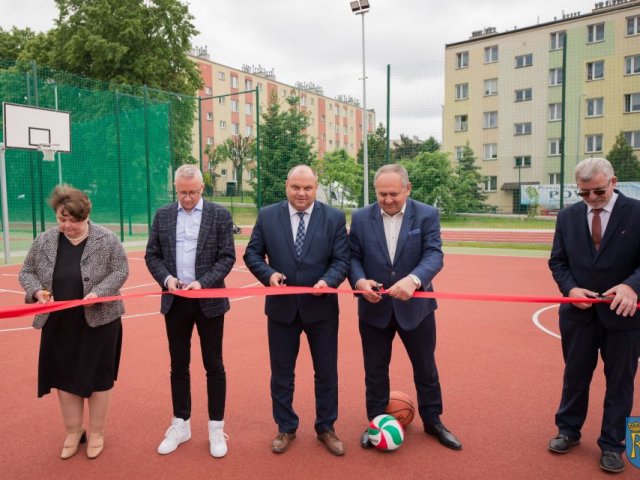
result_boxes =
[443,0,640,213]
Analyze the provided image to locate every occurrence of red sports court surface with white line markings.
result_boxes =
[0,249,640,480]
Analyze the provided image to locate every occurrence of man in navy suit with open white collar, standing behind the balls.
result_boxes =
[349,165,462,450]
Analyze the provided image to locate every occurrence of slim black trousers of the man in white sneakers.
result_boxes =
[165,296,227,421]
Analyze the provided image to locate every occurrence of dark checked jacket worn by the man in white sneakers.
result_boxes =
[144,200,236,318]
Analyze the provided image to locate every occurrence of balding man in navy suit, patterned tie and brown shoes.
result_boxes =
[244,165,349,455]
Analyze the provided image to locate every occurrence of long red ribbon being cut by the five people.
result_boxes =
[0,286,640,319]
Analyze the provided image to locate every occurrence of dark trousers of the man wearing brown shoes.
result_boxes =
[268,316,338,433]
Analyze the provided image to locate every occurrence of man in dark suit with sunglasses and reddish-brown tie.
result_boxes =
[549,158,640,473]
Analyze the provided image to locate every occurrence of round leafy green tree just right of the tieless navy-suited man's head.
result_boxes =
[402,152,455,214]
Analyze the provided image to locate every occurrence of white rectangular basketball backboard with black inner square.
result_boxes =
[2,102,71,153]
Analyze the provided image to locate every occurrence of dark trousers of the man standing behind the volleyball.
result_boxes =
[360,313,442,425]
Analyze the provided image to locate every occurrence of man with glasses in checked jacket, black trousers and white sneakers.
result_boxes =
[144,165,236,457]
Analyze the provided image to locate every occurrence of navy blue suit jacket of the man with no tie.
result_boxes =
[349,198,443,330]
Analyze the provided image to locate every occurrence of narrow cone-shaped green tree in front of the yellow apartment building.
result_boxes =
[452,142,487,213]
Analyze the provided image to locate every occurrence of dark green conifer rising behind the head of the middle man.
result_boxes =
[251,92,315,207]
